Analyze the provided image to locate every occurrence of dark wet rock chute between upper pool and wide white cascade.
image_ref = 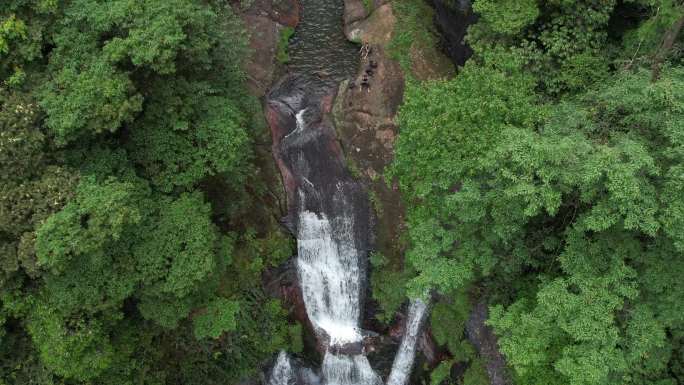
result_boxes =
[266,74,370,237]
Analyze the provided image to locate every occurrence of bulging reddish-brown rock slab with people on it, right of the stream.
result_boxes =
[333,46,404,259]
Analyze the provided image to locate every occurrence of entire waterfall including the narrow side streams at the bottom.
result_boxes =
[269,82,428,385]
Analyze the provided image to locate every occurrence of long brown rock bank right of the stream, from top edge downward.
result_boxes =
[333,0,405,266]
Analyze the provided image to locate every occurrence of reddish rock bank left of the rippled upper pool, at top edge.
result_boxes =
[241,0,301,96]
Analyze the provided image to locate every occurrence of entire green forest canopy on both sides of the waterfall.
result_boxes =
[0,0,684,385]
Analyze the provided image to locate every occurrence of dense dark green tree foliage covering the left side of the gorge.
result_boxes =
[0,0,301,384]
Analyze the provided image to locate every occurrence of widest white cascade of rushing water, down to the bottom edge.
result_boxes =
[297,202,382,385]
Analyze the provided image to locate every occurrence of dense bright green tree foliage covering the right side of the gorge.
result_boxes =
[390,0,684,385]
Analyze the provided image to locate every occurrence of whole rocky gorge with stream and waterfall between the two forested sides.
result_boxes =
[235,0,503,385]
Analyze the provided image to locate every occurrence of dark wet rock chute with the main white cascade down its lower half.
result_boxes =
[266,75,370,353]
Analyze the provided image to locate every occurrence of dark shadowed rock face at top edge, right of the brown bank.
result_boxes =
[432,0,477,66]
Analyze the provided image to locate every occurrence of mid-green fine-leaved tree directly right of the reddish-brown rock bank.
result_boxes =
[389,58,543,293]
